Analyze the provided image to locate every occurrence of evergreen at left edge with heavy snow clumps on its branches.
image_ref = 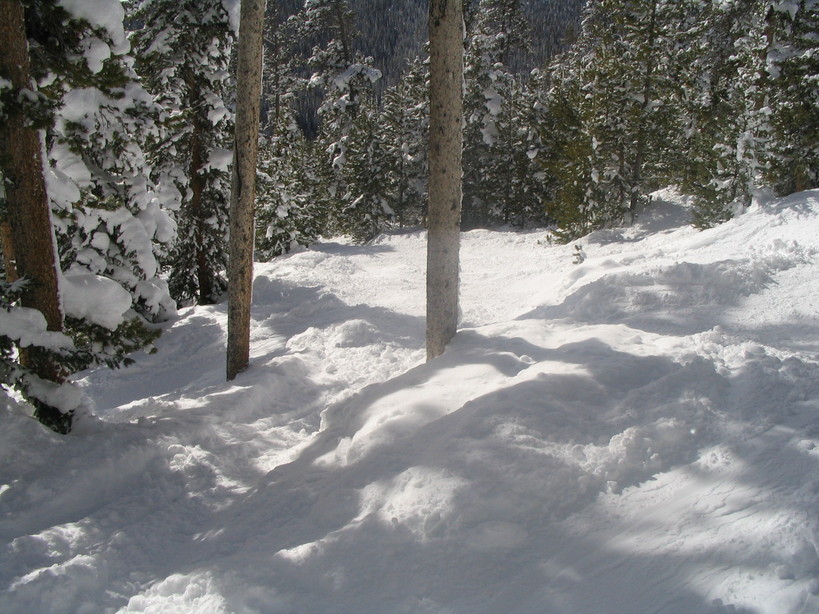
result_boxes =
[3,0,167,432]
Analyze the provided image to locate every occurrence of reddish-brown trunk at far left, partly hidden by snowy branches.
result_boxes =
[0,0,71,432]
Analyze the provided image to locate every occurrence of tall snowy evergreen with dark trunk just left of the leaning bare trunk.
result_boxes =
[132,0,234,304]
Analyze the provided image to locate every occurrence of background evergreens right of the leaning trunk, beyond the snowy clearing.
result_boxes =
[253,0,819,244]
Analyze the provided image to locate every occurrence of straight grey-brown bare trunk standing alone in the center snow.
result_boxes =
[427,0,463,360]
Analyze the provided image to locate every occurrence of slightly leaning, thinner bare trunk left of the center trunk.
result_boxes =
[227,0,265,380]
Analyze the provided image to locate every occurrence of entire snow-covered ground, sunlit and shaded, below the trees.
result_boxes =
[0,191,819,614]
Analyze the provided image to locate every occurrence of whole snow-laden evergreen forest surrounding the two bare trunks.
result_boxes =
[0,0,819,430]
